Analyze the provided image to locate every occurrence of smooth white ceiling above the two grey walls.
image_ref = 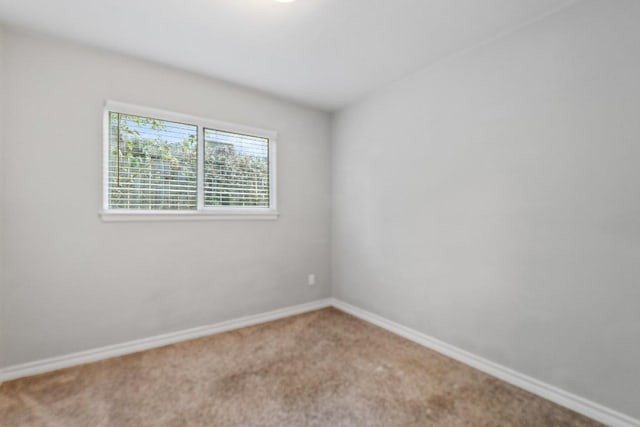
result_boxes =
[0,0,575,110]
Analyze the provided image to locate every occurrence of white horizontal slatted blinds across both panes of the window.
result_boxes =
[106,112,270,210]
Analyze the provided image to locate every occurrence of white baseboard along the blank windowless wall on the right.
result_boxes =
[331,298,640,427]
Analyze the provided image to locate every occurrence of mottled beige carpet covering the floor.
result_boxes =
[0,308,599,427]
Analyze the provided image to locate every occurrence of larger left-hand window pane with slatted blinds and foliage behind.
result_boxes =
[109,112,198,210]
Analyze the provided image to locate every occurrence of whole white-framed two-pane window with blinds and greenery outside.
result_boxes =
[102,102,277,220]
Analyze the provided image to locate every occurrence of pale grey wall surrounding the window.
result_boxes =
[0,30,330,366]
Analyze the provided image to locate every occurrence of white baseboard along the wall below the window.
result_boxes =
[0,298,332,383]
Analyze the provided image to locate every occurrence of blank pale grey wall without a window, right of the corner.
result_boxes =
[332,0,640,417]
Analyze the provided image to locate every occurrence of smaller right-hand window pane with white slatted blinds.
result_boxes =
[204,129,269,207]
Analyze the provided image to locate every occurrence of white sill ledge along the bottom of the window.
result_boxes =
[99,209,280,222]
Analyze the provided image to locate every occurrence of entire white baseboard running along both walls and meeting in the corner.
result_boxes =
[0,298,640,427]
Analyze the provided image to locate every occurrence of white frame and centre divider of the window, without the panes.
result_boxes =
[100,101,279,221]
